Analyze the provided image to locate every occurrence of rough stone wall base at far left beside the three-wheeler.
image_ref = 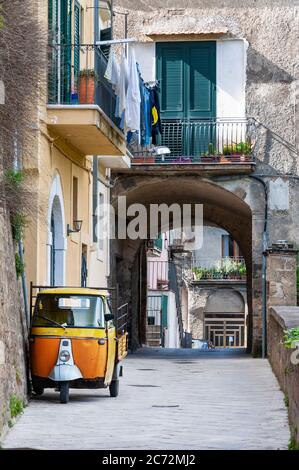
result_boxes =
[0,209,27,436]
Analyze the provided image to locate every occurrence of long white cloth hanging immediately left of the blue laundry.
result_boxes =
[125,48,141,132]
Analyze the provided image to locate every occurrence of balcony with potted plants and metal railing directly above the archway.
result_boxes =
[130,118,256,173]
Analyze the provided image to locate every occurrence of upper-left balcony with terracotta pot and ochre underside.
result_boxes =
[47,45,130,168]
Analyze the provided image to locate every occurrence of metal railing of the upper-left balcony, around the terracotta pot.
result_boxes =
[48,44,120,127]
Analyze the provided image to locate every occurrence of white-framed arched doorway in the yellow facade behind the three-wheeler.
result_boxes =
[47,173,66,286]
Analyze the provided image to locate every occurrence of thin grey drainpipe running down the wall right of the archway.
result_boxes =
[249,175,269,359]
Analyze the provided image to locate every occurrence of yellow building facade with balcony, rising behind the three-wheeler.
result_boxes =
[24,0,130,294]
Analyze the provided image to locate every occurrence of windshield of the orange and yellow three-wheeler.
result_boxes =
[32,294,105,328]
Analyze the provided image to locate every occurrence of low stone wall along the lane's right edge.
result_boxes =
[268,306,299,444]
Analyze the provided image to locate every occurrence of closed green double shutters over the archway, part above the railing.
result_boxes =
[156,41,216,119]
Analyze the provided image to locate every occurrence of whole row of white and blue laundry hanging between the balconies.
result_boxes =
[105,47,162,146]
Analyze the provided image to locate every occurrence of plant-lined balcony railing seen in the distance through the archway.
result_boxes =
[183,257,246,281]
